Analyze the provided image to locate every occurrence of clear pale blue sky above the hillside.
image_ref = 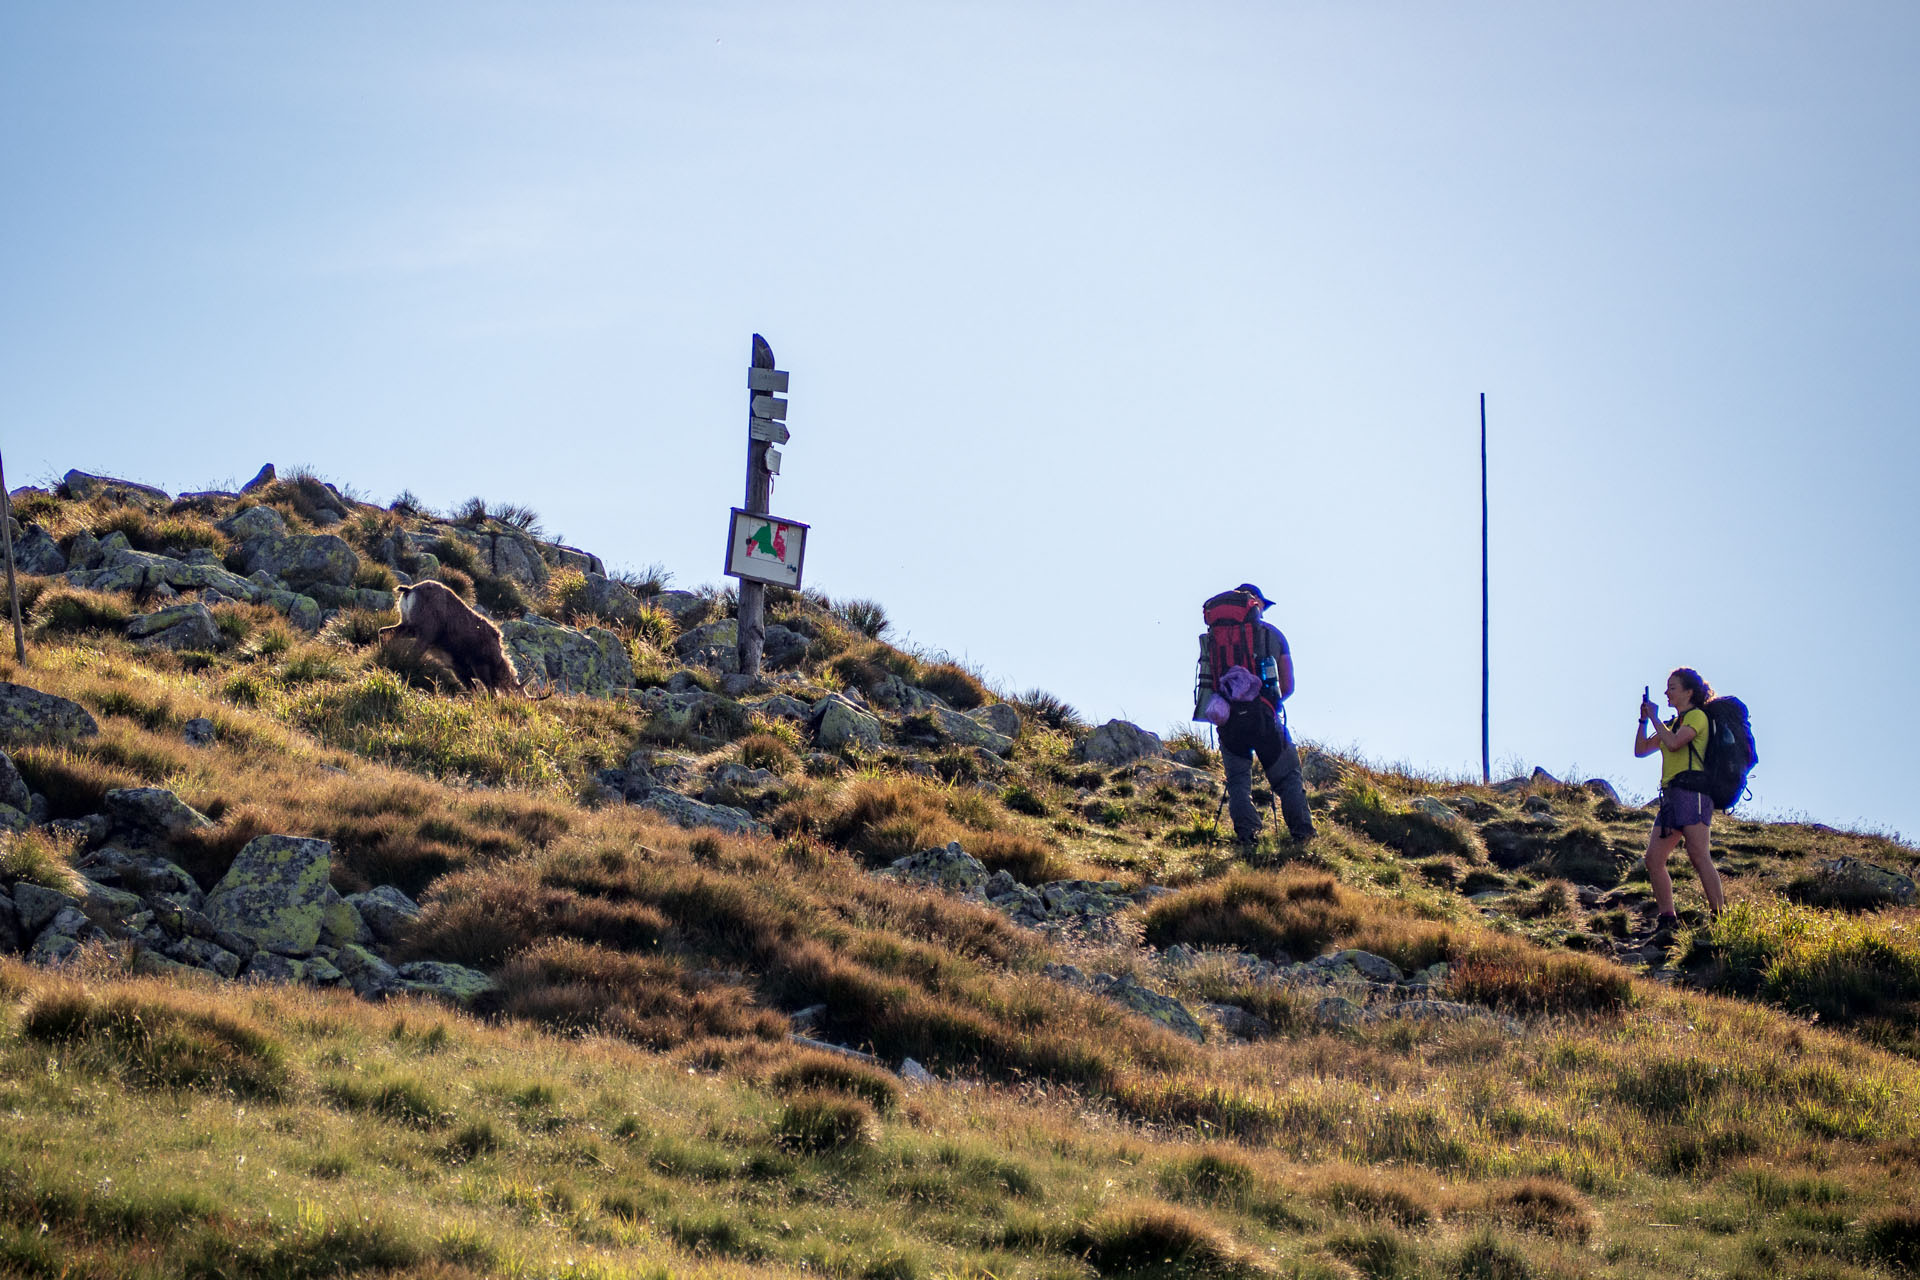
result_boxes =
[0,0,1920,835]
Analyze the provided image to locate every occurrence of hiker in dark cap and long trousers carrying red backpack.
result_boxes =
[1194,581,1313,848]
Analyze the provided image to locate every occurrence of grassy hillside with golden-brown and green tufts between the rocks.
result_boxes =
[0,478,1920,1280]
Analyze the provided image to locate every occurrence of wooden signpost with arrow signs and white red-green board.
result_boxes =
[726,334,806,676]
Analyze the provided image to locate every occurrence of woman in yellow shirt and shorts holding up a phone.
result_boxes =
[1634,666,1757,938]
